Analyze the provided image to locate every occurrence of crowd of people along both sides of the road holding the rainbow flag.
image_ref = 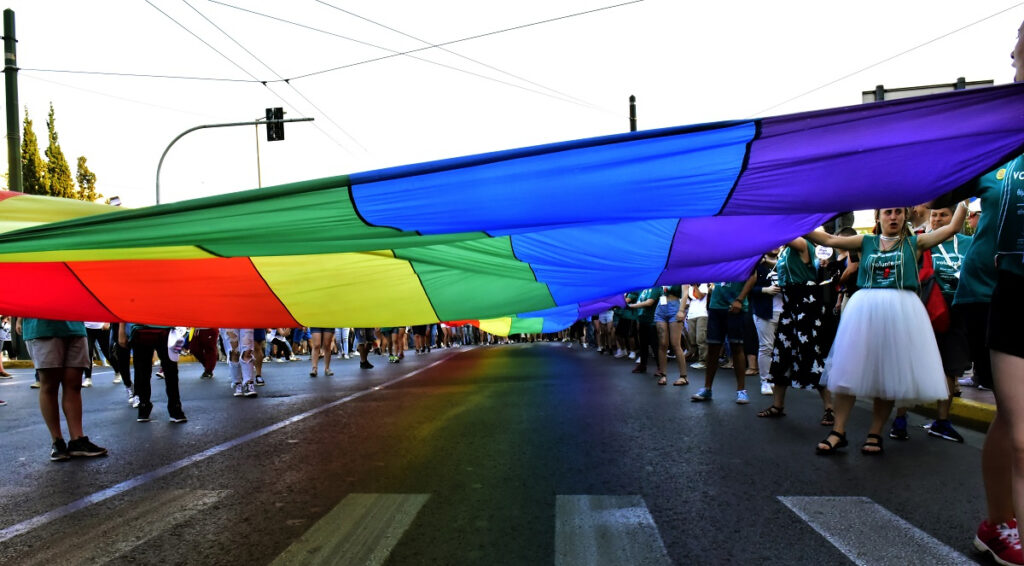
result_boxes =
[0,17,1024,565]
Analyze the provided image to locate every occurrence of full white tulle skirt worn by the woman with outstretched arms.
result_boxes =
[821,289,949,405]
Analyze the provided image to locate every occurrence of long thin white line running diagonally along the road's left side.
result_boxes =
[0,350,460,542]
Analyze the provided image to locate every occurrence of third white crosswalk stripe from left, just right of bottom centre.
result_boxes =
[555,495,672,566]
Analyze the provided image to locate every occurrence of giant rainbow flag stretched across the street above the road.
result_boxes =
[0,85,1024,334]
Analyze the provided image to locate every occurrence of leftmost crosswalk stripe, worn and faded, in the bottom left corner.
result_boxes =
[18,489,229,566]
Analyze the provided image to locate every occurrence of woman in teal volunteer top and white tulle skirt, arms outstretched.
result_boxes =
[807,205,967,455]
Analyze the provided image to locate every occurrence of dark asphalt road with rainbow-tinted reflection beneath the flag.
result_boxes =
[0,343,988,566]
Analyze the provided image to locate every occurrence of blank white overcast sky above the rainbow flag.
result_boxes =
[0,0,1024,207]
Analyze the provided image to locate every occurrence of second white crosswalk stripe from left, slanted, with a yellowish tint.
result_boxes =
[271,493,430,566]
